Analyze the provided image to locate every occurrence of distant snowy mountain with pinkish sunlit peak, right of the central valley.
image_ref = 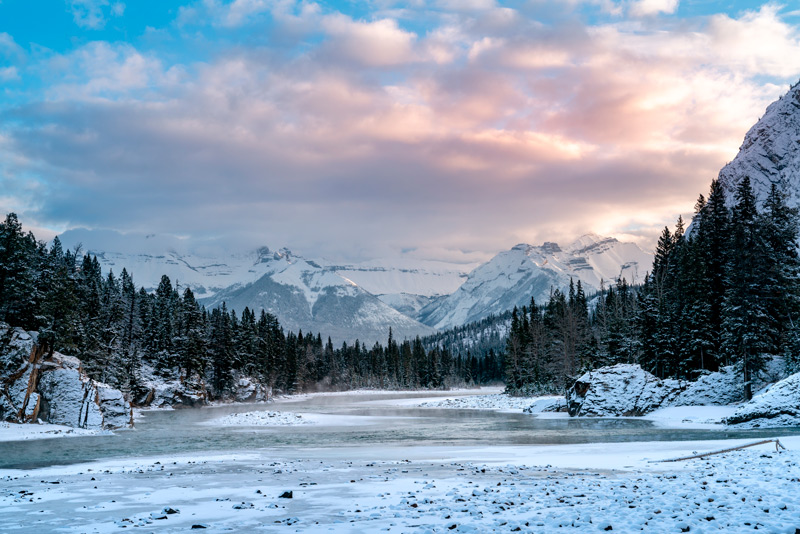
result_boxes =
[419,234,653,329]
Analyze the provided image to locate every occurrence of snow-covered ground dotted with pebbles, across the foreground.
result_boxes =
[0,437,800,534]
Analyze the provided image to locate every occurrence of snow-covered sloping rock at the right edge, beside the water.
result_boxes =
[725,373,800,428]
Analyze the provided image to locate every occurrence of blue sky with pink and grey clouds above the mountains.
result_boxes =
[0,0,800,262]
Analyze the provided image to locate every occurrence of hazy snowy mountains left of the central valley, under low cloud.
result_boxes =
[59,229,460,344]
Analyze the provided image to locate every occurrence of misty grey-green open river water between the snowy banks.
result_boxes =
[0,391,800,469]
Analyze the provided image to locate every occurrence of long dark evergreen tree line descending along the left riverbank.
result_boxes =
[0,213,502,400]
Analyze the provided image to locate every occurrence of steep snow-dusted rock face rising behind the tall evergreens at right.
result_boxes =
[719,83,800,206]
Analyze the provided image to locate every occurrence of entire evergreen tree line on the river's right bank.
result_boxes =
[505,178,800,399]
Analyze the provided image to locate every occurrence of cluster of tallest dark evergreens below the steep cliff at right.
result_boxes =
[637,178,800,398]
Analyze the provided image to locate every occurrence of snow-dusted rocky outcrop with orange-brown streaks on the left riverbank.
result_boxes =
[0,323,133,429]
